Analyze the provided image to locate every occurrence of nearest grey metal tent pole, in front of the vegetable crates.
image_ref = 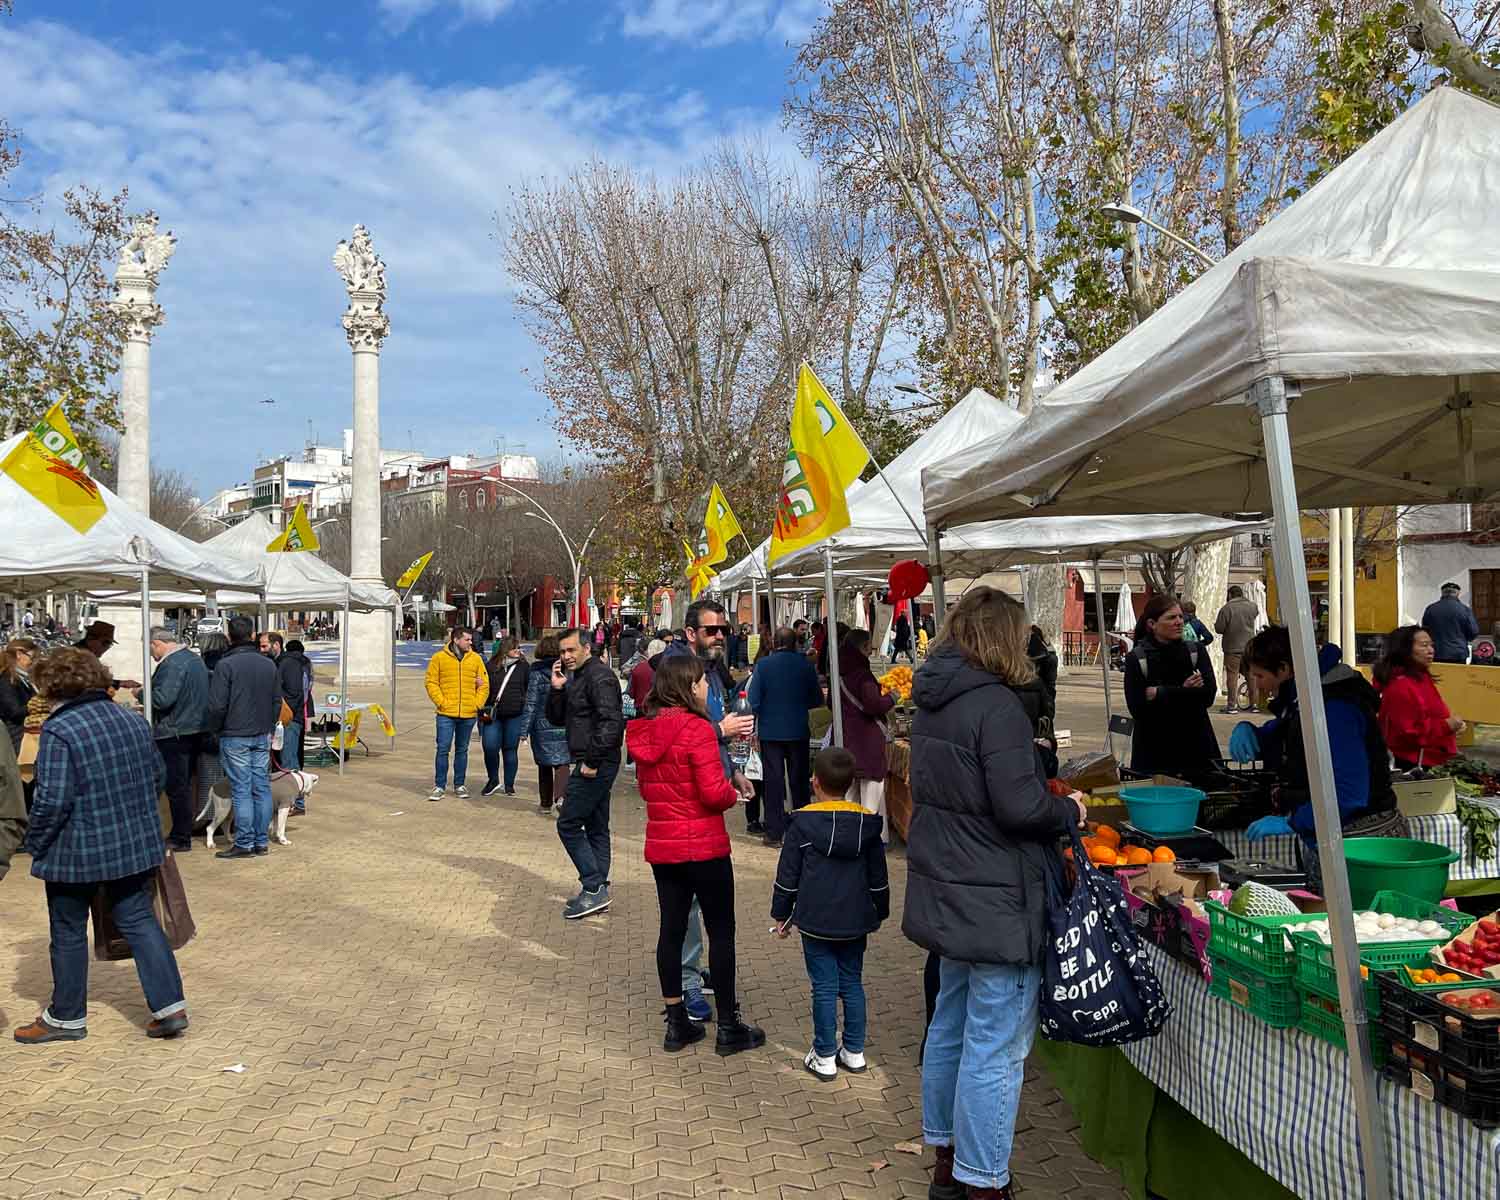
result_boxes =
[1250,377,1391,1200]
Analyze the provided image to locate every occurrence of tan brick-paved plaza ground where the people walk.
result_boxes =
[0,668,1188,1200]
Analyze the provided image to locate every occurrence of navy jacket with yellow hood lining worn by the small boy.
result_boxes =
[771,800,891,941]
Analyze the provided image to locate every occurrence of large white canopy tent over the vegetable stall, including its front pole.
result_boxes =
[924,89,1500,1200]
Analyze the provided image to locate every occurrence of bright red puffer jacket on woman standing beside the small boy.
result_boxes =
[626,708,740,864]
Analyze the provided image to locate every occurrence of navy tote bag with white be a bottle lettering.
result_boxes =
[1040,831,1172,1046]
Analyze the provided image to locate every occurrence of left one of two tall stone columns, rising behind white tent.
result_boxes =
[99,213,177,680]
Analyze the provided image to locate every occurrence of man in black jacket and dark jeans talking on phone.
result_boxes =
[548,629,626,921]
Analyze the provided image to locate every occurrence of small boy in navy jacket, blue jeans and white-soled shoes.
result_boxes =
[771,746,891,1082]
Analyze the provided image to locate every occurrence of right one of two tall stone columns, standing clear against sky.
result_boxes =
[333,225,396,687]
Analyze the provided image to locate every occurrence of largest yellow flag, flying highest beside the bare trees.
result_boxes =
[770,363,870,563]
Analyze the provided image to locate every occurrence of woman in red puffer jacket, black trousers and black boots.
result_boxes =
[626,654,765,1055]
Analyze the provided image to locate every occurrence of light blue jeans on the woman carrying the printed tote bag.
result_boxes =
[923,959,1041,1188]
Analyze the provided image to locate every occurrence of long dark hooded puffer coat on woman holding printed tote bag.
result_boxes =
[902,645,1077,965]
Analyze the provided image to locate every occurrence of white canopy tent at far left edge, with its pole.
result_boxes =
[0,434,266,717]
